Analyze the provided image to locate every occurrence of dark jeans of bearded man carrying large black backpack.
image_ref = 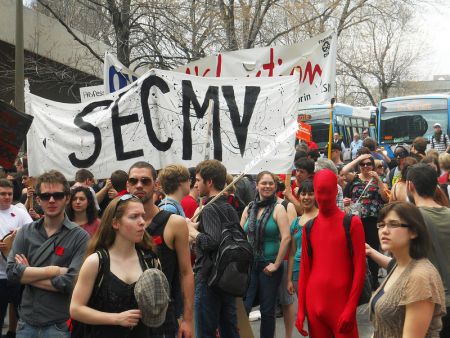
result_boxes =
[194,277,240,338]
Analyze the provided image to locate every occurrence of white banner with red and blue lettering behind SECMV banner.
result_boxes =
[104,31,337,106]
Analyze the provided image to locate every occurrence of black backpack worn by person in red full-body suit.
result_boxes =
[305,214,372,305]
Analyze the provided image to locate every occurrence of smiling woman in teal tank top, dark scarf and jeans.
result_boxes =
[241,171,290,337]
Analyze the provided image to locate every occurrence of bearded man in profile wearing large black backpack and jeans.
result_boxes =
[188,160,239,338]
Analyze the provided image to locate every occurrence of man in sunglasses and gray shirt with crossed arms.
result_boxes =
[6,170,89,338]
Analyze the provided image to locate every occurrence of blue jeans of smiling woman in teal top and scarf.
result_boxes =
[244,261,283,338]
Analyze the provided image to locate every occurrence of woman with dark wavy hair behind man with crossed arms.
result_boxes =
[66,186,100,237]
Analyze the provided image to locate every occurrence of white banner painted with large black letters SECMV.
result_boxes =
[27,70,298,179]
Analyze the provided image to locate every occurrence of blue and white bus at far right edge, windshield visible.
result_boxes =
[378,94,450,146]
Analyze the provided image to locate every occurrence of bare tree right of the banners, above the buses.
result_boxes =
[338,2,423,105]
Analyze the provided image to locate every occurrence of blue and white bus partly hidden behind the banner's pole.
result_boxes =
[298,103,377,149]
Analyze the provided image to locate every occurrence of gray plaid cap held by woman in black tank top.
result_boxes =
[134,268,170,327]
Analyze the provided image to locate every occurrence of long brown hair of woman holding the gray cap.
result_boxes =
[86,197,154,257]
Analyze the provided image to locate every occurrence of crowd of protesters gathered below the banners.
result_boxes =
[0,131,450,338]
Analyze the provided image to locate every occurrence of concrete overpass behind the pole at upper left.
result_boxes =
[0,0,110,102]
